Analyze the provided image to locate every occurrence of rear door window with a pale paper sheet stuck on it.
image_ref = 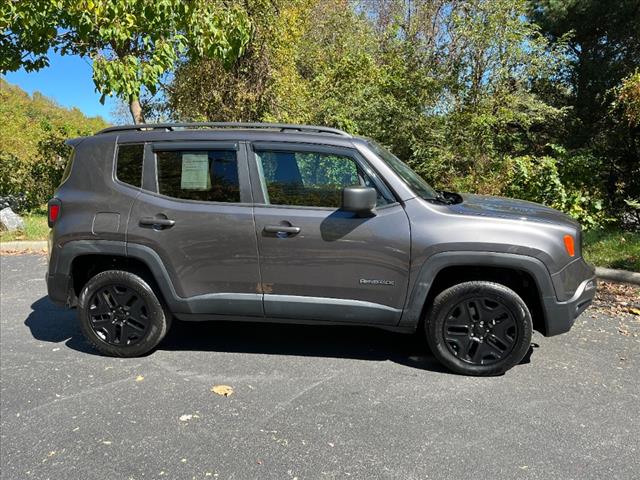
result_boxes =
[156,150,240,203]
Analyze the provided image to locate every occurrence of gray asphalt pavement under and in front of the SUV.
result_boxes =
[0,255,640,480]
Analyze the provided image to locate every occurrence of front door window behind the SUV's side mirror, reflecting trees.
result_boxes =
[256,150,390,208]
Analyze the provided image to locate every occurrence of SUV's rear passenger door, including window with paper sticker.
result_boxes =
[127,142,263,316]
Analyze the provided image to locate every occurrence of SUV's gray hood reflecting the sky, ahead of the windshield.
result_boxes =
[449,193,579,228]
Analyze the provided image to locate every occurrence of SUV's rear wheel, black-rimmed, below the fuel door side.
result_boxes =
[78,270,171,357]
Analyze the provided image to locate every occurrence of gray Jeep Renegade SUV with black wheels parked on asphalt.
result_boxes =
[47,123,596,375]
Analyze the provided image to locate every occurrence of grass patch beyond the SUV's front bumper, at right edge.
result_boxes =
[582,230,640,272]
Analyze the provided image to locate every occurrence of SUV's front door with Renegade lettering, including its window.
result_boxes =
[249,143,410,325]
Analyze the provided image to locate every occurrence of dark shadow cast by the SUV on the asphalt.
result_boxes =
[25,297,537,373]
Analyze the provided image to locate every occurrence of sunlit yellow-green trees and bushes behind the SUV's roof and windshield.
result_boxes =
[166,0,597,217]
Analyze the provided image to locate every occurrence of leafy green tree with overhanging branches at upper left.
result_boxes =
[0,0,251,123]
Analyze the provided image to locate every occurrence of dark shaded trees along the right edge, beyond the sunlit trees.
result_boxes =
[530,0,640,227]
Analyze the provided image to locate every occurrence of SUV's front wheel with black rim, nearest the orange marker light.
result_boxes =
[424,281,533,376]
